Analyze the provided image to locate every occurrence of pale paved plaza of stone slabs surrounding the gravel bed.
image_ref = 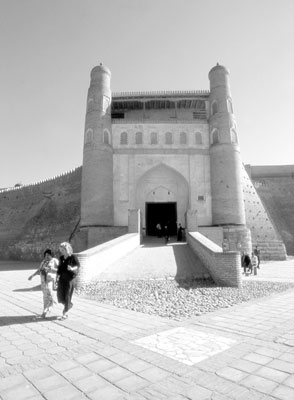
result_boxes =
[0,260,294,400]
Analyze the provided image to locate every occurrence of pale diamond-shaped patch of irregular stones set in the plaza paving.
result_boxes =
[131,327,237,365]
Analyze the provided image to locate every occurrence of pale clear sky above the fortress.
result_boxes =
[0,0,294,188]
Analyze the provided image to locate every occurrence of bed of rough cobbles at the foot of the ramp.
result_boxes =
[77,279,294,320]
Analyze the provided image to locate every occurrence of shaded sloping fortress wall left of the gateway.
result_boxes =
[0,167,82,260]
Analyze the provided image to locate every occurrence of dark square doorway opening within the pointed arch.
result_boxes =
[146,203,177,236]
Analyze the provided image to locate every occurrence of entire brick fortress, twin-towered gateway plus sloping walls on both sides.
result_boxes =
[0,65,288,276]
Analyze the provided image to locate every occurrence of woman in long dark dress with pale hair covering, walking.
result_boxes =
[57,242,80,320]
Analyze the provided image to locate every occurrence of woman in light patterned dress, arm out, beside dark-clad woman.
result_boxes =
[28,249,58,318]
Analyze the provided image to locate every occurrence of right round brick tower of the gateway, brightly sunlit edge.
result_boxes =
[209,64,246,225]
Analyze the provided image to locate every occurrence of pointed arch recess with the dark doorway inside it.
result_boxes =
[136,164,189,235]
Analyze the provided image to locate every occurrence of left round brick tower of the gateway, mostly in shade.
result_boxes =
[80,64,113,227]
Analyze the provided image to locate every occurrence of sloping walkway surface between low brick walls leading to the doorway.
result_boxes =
[98,236,210,281]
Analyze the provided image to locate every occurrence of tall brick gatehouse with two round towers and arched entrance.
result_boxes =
[75,64,252,251]
